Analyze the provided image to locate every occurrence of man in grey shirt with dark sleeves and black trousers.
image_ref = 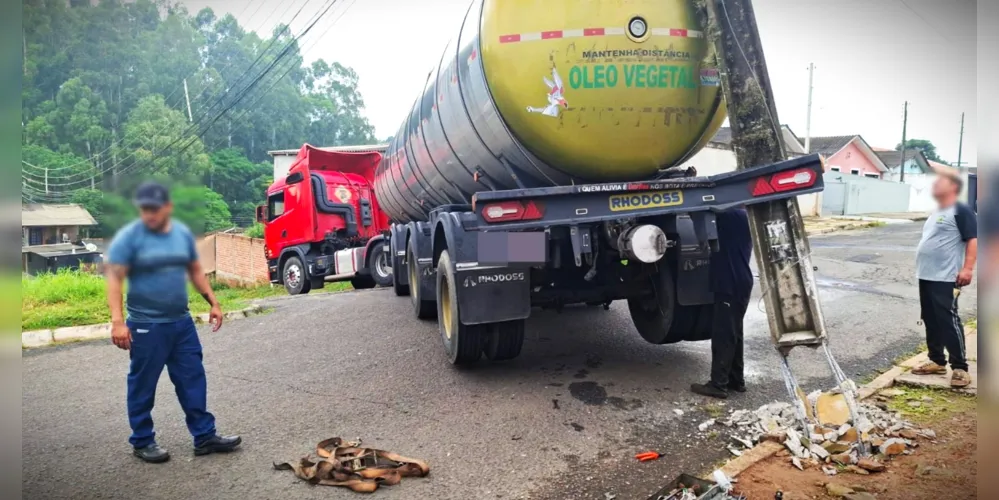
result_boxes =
[912,175,978,387]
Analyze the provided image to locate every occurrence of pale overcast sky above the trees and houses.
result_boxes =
[181,0,978,162]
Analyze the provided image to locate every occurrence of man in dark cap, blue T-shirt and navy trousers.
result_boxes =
[107,182,241,463]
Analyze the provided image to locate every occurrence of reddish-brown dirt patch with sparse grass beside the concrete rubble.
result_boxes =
[737,390,978,500]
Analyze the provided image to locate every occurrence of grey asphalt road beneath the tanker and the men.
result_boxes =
[22,223,977,500]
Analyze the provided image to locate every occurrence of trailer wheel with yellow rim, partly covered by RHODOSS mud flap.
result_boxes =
[437,250,487,365]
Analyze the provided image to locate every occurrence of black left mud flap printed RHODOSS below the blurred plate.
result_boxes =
[455,267,531,325]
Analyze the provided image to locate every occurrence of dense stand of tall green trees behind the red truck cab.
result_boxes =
[21,0,374,209]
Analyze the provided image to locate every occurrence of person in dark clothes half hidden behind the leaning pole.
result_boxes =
[690,208,753,399]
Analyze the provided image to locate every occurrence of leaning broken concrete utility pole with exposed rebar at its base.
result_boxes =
[695,0,858,448]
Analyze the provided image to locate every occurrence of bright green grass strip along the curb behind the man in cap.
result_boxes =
[21,271,286,331]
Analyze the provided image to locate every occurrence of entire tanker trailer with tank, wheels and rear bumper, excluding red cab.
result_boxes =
[262,0,823,365]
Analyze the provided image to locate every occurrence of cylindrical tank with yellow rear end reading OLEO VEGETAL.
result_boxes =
[375,0,725,222]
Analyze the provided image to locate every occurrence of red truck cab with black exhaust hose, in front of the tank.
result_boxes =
[257,144,392,295]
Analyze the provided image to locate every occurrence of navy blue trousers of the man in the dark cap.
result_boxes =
[127,316,215,448]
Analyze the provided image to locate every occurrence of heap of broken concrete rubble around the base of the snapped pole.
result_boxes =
[699,392,936,475]
